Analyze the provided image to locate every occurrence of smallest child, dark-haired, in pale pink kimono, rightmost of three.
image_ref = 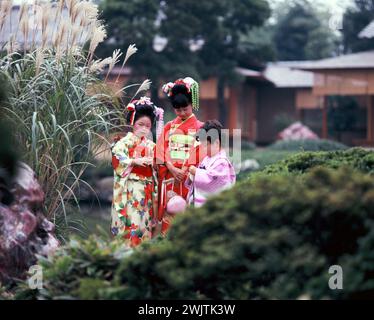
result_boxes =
[186,120,236,207]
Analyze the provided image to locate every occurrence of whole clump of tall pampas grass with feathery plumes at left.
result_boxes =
[0,0,149,238]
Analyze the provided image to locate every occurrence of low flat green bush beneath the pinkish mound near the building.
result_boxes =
[268,139,348,151]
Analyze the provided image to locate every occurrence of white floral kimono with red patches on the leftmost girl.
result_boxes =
[111,132,157,247]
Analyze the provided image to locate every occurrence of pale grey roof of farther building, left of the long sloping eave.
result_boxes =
[237,61,313,88]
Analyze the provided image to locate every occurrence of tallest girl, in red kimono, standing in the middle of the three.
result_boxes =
[156,77,203,234]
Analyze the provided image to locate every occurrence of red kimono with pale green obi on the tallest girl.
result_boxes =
[156,114,204,230]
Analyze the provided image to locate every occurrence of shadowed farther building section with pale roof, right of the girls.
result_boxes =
[229,62,317,144]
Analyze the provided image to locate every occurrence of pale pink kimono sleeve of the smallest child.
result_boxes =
[194,159,230,192]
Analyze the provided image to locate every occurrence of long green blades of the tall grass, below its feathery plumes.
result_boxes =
[2,51,117,235]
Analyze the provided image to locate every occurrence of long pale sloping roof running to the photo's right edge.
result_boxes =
[295,50,374,71]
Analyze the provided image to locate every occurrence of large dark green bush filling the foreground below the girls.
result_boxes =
[13,168,374,299]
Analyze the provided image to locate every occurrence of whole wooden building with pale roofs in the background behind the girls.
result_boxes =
[104,51,374,145]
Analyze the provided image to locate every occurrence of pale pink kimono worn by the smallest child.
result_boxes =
[185,150,236,207]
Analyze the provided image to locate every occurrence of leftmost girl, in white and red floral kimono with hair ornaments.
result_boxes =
[111,97,157,247]
